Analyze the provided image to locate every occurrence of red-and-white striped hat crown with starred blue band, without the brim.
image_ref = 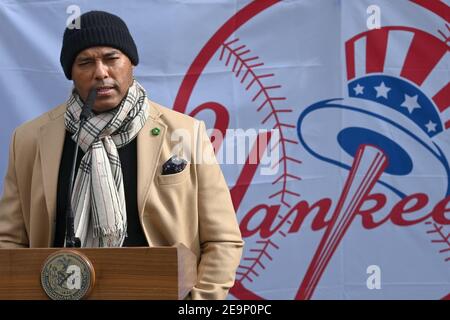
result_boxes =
[345,27,450,137]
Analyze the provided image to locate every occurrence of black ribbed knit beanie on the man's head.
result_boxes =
[60,11,139,80]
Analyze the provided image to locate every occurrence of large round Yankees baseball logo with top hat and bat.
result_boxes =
[174,0,450,299]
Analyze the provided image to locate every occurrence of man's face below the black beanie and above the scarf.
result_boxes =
[72,47,133,112]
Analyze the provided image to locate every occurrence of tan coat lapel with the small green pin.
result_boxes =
[137,101,167,217]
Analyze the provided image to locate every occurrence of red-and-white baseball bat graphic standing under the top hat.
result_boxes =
[295,145,388,300]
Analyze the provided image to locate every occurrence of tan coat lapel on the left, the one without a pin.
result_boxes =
[39,105,66,239]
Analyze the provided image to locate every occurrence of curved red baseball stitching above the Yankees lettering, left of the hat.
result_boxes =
[219,38,302,207]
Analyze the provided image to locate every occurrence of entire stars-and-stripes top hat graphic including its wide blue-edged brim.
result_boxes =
[298,27,450,199]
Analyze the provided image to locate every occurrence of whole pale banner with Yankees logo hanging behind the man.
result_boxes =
[0,0,450,299]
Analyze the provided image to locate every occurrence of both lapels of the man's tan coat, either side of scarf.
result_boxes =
[38,100,167,241]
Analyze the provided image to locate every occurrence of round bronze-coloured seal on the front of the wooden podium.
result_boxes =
[41,250,95,300]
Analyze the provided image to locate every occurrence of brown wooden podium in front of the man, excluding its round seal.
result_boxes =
[0,244,197,300]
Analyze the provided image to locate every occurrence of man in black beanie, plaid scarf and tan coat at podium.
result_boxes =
[0,11,243,299]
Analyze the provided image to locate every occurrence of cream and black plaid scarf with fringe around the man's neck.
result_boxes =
[65,81,148,247]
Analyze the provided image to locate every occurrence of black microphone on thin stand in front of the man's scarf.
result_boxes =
[66,87,97,248]
